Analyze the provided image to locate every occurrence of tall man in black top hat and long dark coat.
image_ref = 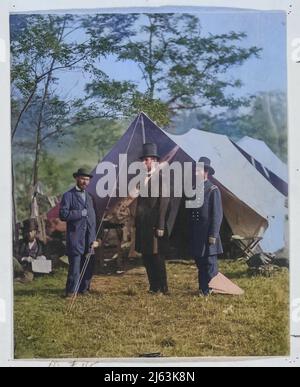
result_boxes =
[135,143,170,294]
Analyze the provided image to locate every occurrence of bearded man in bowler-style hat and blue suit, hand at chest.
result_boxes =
[59,169,99,297]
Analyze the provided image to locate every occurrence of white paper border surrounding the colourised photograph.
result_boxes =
[0,0,300,367]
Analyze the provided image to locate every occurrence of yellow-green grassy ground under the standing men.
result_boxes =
[14,261,289,359]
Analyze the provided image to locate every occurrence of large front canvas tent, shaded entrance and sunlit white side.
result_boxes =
[85,113,285,252]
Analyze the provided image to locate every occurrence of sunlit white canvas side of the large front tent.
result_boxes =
[166,129,287,253]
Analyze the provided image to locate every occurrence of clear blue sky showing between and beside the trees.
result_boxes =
[51,10,287,102]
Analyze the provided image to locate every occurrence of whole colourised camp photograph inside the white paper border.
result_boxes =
[0,2,290,359]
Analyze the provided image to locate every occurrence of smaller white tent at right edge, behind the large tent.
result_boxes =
[235,136,288,197]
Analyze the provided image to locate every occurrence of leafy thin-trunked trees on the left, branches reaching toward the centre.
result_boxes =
[11,15,135,223]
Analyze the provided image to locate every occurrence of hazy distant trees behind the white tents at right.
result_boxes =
[178,91,287,161]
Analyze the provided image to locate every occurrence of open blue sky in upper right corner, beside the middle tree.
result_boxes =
[200,12,287,94]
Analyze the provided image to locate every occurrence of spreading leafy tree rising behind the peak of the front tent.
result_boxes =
[88,14,260,125]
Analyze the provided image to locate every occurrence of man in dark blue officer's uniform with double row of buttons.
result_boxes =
[189,157,223,296]
